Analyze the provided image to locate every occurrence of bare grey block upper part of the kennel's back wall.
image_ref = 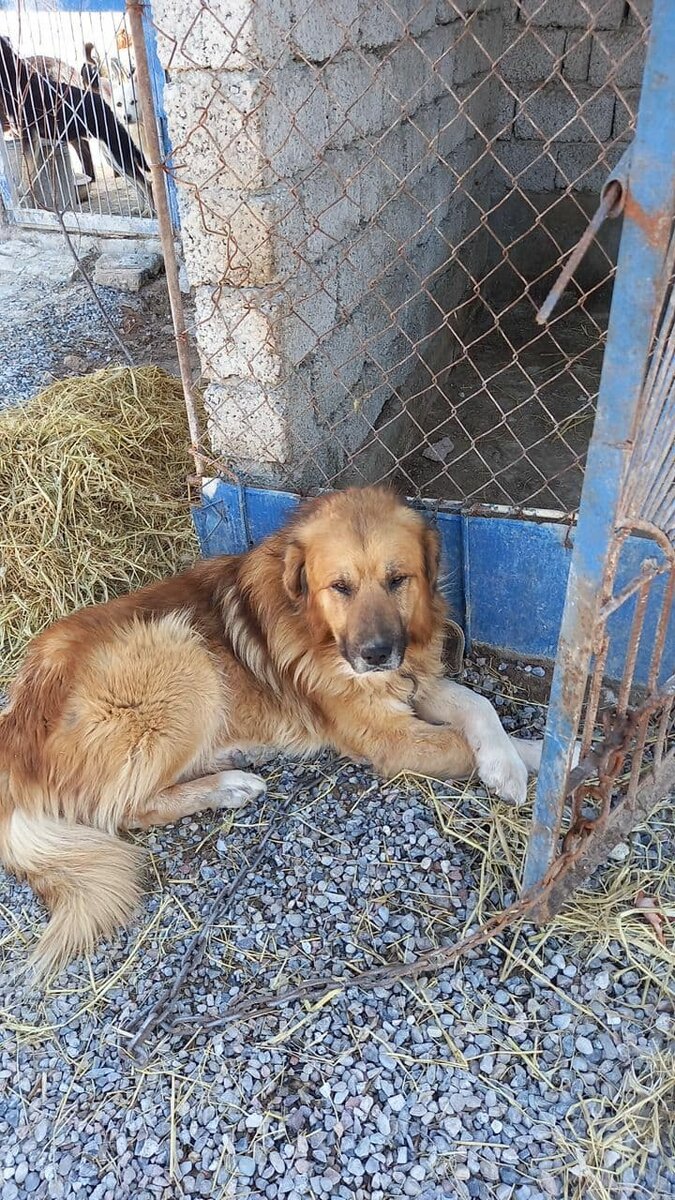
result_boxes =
[495,0,649,194]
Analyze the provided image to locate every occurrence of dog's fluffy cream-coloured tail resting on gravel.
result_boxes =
[0,810,142,979]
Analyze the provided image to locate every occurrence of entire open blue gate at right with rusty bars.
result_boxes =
[524,0,675,902]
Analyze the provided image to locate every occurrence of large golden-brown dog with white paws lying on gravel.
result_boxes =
[0,488,540,972]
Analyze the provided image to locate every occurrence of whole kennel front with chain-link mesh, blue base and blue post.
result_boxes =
[130,0,675,902]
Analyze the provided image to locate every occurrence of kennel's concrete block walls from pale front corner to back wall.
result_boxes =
[153,0,641,487]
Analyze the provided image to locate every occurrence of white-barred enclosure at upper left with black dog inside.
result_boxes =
[0,0,175,235]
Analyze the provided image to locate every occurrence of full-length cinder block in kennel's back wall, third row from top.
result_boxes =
[515,84,614,142]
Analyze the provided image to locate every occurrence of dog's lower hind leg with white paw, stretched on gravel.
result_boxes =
[129,770,265,829]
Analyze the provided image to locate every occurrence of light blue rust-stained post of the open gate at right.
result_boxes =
[524,0,675,889]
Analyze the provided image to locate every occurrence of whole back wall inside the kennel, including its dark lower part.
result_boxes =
[489,0,651,304]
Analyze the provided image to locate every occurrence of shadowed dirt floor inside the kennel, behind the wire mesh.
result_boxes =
[344,300,608,511]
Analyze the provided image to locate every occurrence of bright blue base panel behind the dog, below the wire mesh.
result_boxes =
[193,479,675,683]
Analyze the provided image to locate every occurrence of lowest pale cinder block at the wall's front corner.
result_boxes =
[204,379,292,464]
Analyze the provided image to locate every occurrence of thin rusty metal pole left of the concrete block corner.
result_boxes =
[121,0,205,480]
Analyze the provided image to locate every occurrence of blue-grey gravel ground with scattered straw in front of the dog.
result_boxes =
[0,662,675,1200]
